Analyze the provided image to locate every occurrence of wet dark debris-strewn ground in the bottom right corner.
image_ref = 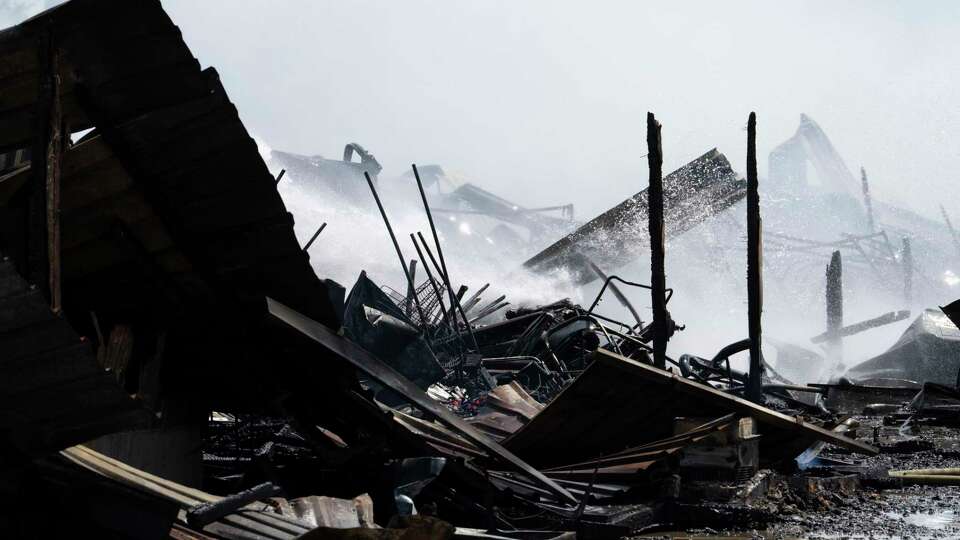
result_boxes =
[635,417,960,540]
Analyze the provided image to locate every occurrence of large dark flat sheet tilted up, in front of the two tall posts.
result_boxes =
[504,350,876,467]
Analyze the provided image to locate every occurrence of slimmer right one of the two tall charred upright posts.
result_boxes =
[746,112,763,402]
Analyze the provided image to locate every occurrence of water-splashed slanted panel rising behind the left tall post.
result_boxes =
[524,149,747,284]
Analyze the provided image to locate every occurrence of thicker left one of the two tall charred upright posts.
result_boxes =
[647,112,669,369]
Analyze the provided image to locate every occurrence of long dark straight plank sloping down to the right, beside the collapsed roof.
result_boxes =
[267,298,577,504]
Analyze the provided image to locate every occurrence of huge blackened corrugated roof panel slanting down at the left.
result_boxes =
[0,0,337,330]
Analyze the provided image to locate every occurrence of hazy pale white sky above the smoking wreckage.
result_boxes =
[7,0,960,218]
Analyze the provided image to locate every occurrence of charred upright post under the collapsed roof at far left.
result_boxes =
[25,28,65,313]
